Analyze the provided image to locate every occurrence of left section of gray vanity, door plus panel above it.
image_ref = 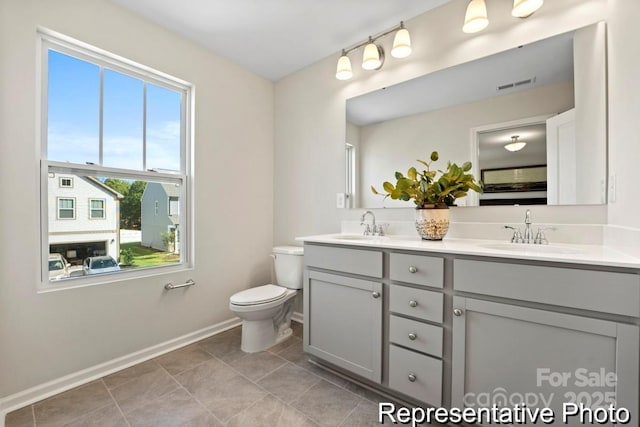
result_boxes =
[304,245,383,383]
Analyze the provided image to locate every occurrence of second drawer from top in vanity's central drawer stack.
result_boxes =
[389,285,444,323]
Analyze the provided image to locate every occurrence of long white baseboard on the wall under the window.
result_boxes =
[0,317,242,427]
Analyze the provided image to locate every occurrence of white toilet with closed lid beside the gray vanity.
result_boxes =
[229,246,304,353]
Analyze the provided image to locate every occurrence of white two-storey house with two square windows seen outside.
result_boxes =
[48,173,124,264]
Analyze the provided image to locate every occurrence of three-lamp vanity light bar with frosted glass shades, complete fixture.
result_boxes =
[336,22,411,80]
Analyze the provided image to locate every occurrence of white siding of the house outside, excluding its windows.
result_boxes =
[48,173,120,259]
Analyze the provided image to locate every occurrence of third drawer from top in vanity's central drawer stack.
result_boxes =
[389,315,442,357]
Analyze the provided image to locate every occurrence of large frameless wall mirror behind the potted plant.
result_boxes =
[346,22,607,208]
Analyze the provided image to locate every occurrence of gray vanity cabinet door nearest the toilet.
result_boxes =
[304,271,382,383]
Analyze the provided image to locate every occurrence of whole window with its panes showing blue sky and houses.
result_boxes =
[39,31,192,288]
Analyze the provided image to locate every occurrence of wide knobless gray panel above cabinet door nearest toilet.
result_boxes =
[304,244,382,278]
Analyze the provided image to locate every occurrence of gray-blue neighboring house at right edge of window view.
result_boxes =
[141,182,180,253]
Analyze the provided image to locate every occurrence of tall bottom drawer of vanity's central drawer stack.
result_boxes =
[389,345,442,406]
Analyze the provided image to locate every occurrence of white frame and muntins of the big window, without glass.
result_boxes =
[37,28,195,292]
